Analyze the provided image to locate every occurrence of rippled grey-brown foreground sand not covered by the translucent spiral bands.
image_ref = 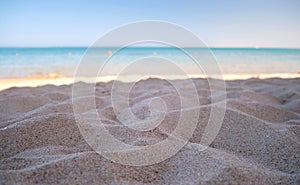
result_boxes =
[0,78,300,184]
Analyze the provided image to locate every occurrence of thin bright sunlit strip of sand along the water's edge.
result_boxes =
[0,72,300,91]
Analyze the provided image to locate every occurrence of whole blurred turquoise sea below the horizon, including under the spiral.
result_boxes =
[0,47,300,78]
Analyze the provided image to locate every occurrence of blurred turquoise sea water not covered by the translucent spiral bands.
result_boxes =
[0,47,300,78]
